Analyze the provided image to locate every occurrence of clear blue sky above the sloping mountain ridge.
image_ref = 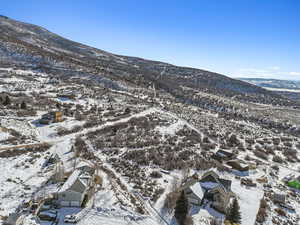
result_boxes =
[0,0,300,80]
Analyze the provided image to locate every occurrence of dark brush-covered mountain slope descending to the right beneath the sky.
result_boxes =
[0,16,294,105]
